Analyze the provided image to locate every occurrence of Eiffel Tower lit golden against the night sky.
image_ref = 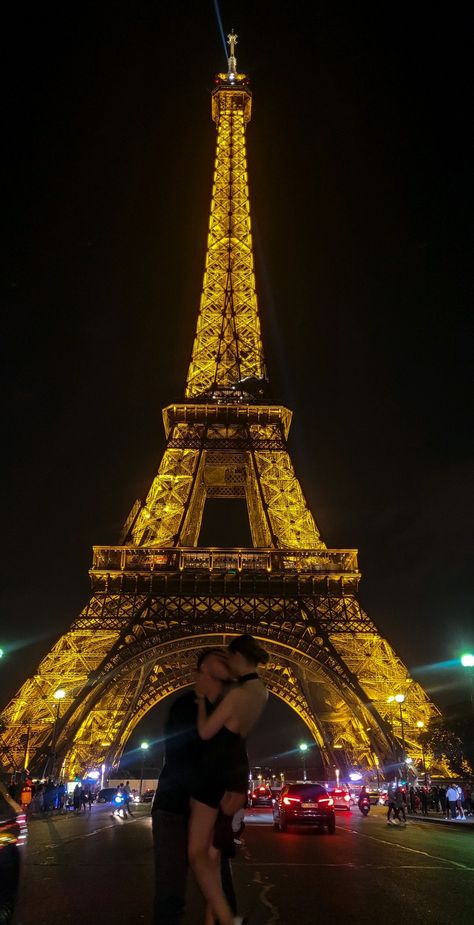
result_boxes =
[0,33,438,777]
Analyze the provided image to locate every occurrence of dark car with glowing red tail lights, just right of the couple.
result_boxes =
[273,783,336,835]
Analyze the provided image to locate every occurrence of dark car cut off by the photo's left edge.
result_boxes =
[0,783,27,925]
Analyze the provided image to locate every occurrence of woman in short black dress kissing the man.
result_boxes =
[188,633,268,925]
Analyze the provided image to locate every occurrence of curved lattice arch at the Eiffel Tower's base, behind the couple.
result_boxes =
[52,627,400,774]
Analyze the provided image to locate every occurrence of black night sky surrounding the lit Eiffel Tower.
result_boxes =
[0,0,474,760]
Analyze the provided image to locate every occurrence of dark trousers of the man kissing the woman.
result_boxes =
[151,809,237,925]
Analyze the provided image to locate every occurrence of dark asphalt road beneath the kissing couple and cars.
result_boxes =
[14,806,474,925]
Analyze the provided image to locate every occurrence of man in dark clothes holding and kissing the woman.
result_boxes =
[151,648,241,925]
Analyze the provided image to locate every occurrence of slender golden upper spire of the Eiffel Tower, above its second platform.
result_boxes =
[186,38,267,402]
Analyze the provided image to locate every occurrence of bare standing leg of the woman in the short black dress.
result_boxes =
[188,800,234,925]
